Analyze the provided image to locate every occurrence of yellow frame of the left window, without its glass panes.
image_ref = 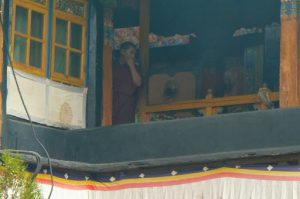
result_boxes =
[11,0,48,76]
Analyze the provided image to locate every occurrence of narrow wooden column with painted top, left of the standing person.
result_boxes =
[102,8,113,126]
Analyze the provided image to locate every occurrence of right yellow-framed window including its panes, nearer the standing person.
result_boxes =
[51,0,86,86]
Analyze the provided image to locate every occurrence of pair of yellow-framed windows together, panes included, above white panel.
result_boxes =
[11,0,87,86]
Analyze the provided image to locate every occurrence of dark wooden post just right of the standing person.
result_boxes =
[138,0,150,122]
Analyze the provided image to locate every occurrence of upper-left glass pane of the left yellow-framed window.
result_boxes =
[15,6,28,34]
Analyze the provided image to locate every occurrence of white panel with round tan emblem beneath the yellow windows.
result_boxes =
[6,67,87,129]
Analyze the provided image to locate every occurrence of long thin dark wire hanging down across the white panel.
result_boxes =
[0,6,54,199]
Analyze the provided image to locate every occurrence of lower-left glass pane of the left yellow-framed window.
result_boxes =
[14,35,27,64]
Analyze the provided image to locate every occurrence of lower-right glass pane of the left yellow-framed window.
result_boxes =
[30,41,43,68]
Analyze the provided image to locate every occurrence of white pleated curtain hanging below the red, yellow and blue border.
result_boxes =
[41,178,300,199]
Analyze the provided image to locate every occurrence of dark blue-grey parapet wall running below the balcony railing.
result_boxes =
[4,108,300,168]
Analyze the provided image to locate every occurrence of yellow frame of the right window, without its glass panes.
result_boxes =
[51,0,87,86]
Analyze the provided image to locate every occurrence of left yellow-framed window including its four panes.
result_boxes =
[12,0,48,76]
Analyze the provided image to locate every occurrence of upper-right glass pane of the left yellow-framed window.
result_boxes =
[31,11,44,39]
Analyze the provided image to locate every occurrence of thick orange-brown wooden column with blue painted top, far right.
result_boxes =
[280,0,300,108]
